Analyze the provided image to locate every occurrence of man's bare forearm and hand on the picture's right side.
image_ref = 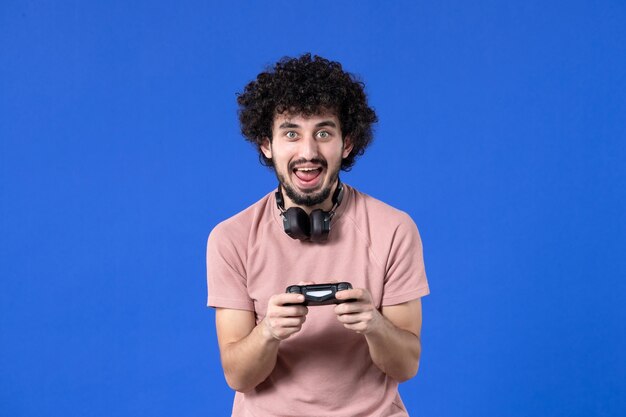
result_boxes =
[335,288,422,382]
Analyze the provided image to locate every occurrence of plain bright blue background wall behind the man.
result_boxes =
[0,0,626,417]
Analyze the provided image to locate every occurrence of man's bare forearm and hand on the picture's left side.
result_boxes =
[215,293,308,392]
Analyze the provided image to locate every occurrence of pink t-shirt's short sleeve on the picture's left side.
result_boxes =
[206,223,254,311]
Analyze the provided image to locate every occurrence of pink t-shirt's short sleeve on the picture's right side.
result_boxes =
[382,213,430,306]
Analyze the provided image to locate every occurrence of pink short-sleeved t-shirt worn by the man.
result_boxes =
[207,186,429,417]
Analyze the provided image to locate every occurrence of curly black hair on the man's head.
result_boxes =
[237,53,378,171]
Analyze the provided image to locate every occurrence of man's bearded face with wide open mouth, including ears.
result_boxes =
[261,113,352,209]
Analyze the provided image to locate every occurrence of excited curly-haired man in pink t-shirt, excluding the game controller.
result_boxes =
[207,54,429,417]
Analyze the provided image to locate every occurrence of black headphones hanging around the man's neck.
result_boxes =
[275,181,343,243]
